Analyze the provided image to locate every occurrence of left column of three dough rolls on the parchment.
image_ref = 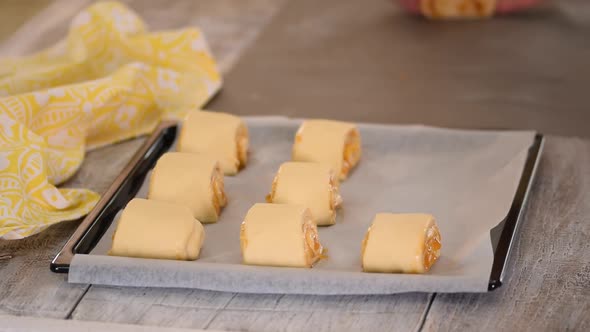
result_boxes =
[109,111,249,260]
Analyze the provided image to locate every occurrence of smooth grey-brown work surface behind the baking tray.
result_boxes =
[210,0,590,137]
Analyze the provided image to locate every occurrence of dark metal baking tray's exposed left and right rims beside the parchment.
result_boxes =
[51,122,543,290]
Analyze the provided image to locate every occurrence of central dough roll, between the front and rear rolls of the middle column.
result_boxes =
[267,161,342,226]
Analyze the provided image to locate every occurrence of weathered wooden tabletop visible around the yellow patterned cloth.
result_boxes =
[0,0,282,318]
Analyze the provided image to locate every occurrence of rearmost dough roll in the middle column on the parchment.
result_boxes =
[293,120,361,180]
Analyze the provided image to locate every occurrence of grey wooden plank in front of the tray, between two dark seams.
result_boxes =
[72,286,431,331]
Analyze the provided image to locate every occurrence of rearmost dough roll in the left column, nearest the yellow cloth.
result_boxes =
[178,111,249,175]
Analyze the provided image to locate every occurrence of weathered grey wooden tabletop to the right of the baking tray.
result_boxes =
[424,137,590,331]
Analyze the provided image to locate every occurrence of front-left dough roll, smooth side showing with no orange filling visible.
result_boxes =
[109,198,205,260]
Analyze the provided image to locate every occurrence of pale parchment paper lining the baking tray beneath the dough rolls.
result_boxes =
[68,117,535,294]
